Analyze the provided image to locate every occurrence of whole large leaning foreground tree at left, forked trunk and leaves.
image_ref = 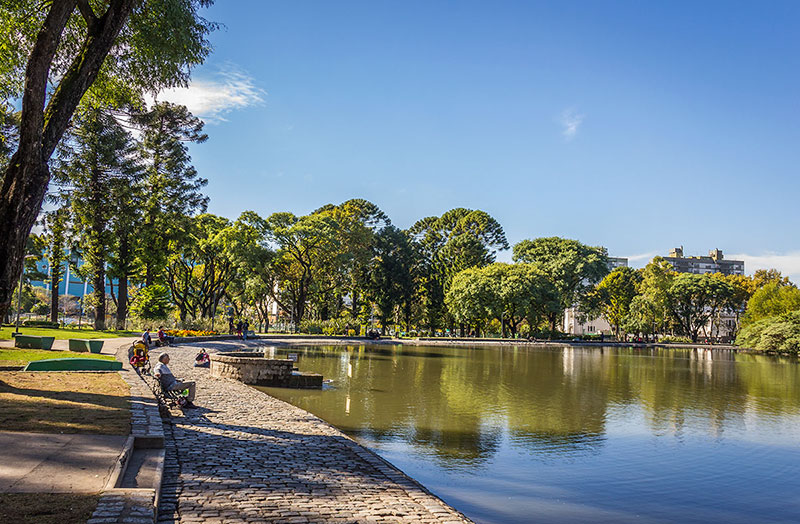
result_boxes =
[0,0,214,317]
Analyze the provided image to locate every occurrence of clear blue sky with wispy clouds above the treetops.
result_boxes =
[160,0,800,281]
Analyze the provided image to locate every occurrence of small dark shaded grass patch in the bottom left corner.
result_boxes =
[0,493,100,524]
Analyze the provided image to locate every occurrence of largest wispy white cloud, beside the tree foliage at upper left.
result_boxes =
[157,71,267,122]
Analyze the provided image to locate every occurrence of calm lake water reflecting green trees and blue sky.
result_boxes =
[256,346,800,523]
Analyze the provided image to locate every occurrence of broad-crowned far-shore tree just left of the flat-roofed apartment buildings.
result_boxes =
[513,237,608,331]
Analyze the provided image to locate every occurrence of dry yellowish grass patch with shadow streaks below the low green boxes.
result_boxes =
[0,371,130,434]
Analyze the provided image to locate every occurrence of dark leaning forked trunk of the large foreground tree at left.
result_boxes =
[0,0,137,317]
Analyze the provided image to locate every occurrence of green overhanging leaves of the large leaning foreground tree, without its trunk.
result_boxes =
[0,0,217,102]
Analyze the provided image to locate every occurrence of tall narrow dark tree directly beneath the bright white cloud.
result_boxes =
[133,102,208,286]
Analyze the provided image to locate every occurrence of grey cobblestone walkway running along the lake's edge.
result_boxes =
[154,346,470,523]
